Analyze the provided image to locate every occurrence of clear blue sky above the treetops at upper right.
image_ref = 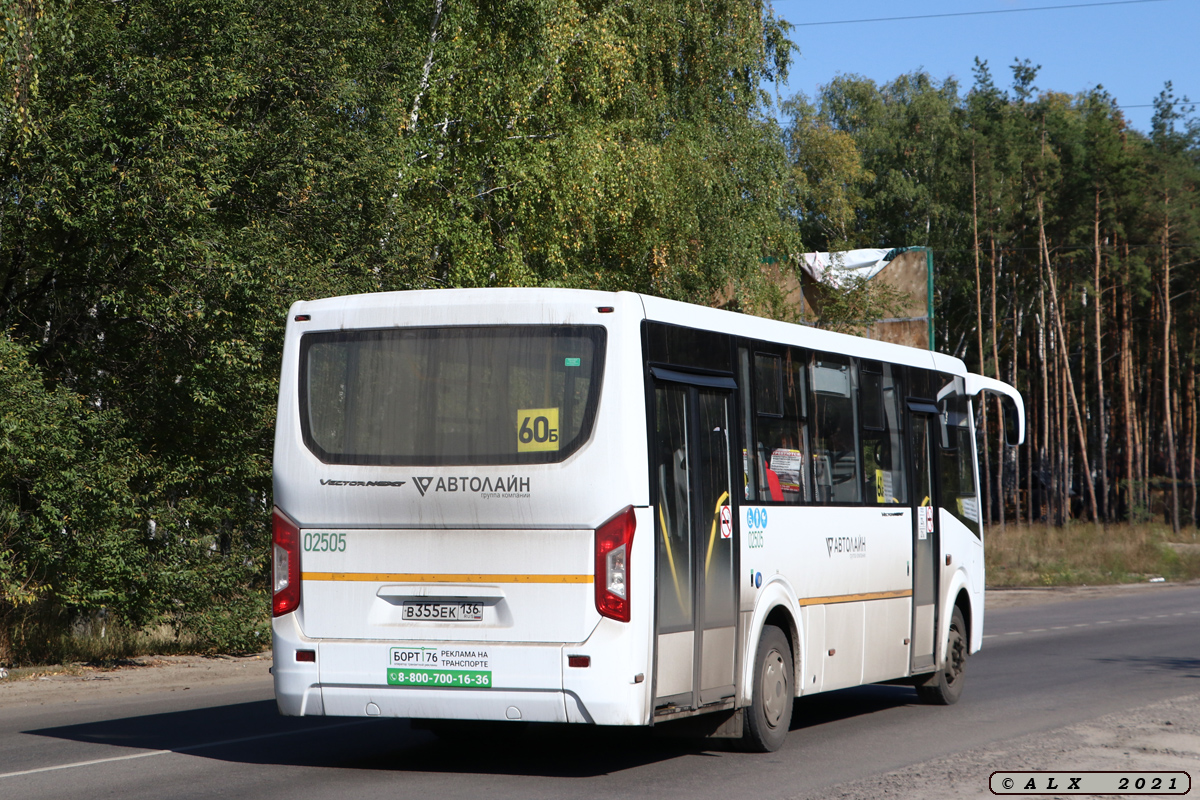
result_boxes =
[772,0,1200,131]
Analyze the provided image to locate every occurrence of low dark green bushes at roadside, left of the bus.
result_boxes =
[0,335,268,663]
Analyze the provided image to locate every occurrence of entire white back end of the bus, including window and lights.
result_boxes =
[272,291,653,724]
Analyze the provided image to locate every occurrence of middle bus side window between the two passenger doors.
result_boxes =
[811,353,863,504]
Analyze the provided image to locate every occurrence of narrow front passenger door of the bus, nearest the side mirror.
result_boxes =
[910,412,941,674]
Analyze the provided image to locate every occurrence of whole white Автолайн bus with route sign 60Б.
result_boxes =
[272,289,1025,751]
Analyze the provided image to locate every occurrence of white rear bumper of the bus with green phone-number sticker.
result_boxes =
[272,614,649,726]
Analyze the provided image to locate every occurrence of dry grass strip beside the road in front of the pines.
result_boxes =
[984,522,1200,587]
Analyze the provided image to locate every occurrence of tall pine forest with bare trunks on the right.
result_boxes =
[786,61,1200,524]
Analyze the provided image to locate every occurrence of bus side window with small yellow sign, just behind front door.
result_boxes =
[859,361,908,505]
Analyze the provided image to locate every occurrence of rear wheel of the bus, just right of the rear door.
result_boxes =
[740,625,796,753]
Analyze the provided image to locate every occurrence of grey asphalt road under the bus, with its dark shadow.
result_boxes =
[0,587,1200,800]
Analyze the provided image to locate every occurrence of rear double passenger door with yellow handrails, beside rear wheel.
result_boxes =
[653,379,737,710]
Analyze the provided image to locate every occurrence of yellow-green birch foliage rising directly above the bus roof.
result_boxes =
[385,0,794,305]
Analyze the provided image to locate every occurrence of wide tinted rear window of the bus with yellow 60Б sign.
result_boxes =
[300,325,605,465]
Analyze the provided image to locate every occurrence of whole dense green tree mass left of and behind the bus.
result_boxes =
[0,0,798,658]
